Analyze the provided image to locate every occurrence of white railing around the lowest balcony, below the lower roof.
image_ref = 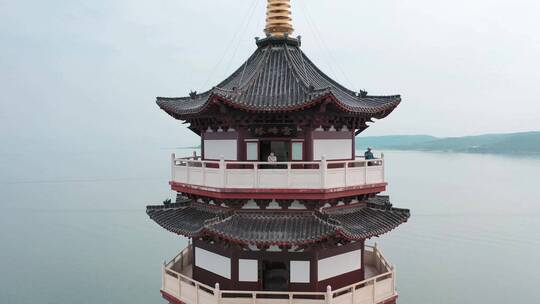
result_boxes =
[162,245,397,304]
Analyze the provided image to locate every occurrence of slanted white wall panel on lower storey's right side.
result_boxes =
[318,250,362,281]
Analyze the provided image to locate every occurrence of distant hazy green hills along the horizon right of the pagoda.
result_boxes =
[356,132,540,155]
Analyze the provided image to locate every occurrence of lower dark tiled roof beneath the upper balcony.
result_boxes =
[146,196,410,246]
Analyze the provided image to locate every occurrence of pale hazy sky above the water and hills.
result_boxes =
[0,0,540,149]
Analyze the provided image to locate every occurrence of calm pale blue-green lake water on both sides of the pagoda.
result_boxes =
[0,149,540,304]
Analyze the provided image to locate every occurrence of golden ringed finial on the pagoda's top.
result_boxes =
[264,0,294,37]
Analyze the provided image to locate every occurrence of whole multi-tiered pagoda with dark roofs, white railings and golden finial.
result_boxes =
[147,0,410,304]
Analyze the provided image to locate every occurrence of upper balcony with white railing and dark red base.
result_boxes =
[171,154,386,199]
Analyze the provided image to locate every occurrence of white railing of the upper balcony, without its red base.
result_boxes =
[171,154,385,189]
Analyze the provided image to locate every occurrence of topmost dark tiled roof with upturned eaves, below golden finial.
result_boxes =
[157,37,401,119]
